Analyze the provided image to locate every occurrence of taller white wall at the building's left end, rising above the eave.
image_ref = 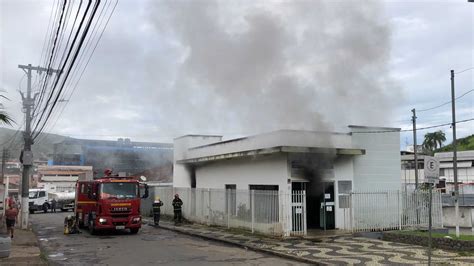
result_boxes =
[173,135,222,187]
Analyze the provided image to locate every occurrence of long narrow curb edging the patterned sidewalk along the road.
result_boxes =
[144,220,327,265]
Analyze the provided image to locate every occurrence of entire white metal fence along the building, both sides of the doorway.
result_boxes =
[142,187,443,236]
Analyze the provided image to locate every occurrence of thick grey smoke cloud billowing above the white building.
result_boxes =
[148,0,398,133]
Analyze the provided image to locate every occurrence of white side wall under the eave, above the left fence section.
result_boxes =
[196,154,291,192]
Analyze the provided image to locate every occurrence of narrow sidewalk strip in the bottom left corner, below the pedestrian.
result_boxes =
[0,228,48,265]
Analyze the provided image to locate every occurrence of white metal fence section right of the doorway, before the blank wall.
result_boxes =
[349,191,443,231]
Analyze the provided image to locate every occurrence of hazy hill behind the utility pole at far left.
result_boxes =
[0,127,66,160]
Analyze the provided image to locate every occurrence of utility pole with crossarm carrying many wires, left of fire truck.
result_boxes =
[18,64,60,229]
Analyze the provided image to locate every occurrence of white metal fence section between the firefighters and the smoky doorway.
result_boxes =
[152,187,306,235]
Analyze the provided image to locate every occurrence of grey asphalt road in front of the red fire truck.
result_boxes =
[30,212,301,266]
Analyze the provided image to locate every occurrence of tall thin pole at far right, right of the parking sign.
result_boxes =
[451,70,459,237]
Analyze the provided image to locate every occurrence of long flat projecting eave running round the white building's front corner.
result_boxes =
[177,146,365,164]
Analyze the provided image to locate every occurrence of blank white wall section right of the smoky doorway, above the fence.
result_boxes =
[351,127,401,191]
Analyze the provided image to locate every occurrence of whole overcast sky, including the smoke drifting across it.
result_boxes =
[0,0,474,148]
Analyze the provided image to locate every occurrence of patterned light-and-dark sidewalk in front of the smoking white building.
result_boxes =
[144,218,474,265]
